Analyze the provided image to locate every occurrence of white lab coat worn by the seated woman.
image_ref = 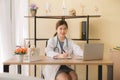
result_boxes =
[43,36,83,80]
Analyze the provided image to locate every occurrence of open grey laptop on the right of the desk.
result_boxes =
[79,43,104,60]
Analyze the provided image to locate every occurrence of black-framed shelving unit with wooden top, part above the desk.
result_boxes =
[25,15,101,46]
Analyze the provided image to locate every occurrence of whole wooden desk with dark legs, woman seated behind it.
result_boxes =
[4,56,113,80]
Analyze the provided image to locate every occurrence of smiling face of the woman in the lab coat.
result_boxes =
[56,24,68,37]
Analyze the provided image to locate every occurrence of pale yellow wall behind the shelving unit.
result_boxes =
[29,0,120,80]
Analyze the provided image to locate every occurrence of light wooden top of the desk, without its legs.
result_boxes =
[3,56,113,65]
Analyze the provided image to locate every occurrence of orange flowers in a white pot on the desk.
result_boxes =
[14,47,27,62]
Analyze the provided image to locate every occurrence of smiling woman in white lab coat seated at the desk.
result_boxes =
[43,20,83,80]
